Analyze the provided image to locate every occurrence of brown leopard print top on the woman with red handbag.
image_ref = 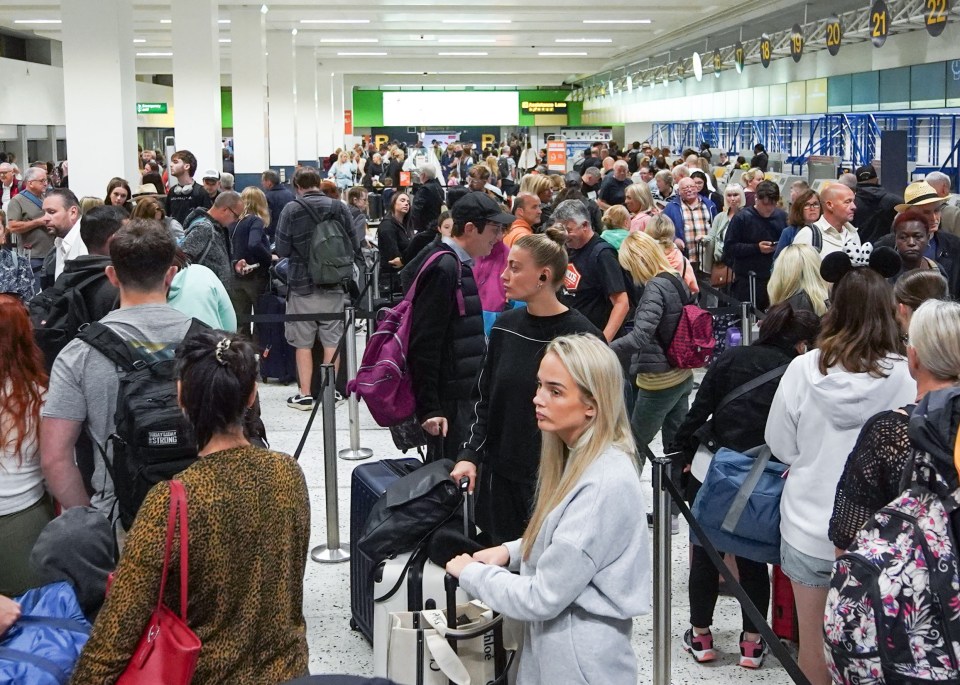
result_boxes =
[70,446,310,685]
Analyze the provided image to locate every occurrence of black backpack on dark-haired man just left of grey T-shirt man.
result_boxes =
[29,271,113,374]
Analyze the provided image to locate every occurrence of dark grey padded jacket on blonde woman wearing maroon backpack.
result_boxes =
[610,274,690,377]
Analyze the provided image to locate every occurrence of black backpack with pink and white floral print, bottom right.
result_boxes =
[824,450,960,685]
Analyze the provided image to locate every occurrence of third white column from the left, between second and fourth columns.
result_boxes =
[230,7,269,174]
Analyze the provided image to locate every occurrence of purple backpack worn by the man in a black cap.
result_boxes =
[347,250,466,428]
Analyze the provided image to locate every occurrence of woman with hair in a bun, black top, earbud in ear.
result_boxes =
[451,228,602,545]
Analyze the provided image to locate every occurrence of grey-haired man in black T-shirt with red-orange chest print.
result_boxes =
[550,200,633,342]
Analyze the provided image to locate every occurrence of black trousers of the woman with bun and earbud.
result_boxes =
[476,468,537,545]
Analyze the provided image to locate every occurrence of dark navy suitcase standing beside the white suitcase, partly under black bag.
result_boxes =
[350,459,423,644]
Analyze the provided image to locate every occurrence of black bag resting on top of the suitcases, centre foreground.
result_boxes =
[357,459,463,565]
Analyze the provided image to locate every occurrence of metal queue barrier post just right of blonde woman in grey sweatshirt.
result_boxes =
[653,456,672,685]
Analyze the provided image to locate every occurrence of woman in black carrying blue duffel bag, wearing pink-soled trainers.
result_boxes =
[671,302,820,668]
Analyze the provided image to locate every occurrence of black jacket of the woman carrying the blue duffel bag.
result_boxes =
[673,344,796,464]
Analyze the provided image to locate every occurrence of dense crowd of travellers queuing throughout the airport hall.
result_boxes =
[0,137,960,685]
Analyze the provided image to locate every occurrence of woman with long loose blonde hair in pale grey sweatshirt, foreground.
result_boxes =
[447,334,651,685]
